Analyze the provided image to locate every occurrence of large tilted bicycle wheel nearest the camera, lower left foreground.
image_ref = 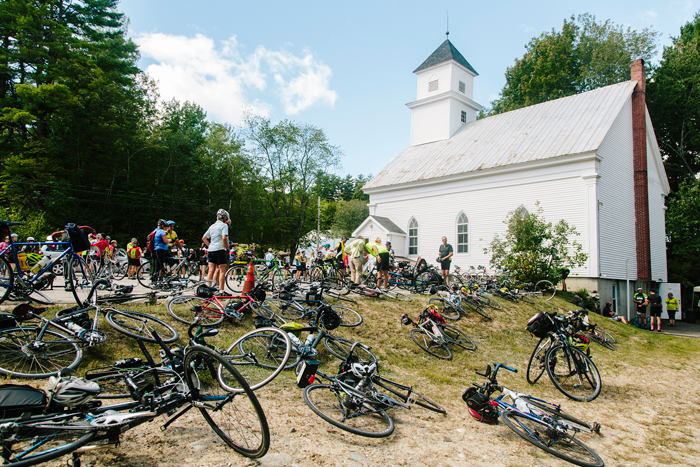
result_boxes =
[184,345,270,459]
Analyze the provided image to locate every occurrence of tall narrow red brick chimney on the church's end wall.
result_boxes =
[632,59,651,281]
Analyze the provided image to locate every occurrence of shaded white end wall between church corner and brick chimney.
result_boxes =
[597,97,637,280]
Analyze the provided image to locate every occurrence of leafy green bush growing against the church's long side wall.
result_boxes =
[484,203,588,284]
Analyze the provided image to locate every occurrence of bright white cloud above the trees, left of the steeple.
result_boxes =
[135,33,338,123]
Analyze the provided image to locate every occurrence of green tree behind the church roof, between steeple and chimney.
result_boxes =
[490,13,659,117]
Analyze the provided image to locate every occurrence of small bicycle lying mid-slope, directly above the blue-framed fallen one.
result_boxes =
[401,306,476,360]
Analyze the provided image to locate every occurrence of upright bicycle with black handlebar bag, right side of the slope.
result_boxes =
[527,312,602,402]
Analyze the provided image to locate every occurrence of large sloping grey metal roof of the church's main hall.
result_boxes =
[363,81,636,189]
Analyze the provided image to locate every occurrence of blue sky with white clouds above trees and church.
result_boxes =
[118,0,700,175]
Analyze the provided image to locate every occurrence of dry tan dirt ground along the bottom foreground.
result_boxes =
[28,356,700,467]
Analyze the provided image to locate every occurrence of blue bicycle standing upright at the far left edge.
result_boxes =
[0,221,93,307]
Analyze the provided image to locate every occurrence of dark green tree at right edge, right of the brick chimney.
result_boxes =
[647,13,700,190]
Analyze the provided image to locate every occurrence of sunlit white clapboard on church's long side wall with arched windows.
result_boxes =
[372,167,594,277]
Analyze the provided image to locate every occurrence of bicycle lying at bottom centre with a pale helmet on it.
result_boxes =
[299,342,445,438]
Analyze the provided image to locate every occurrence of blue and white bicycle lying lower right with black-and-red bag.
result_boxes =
[462,363,604,467]
